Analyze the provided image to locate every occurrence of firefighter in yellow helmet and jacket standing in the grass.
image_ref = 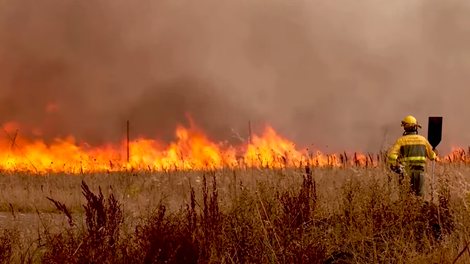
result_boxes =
[388,116,437,198]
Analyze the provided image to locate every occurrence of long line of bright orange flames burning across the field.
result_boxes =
[0,119,462,174]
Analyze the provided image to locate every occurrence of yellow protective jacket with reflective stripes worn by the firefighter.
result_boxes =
[388,134,436,167]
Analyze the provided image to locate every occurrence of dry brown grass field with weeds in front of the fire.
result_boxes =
[0,160,470,264]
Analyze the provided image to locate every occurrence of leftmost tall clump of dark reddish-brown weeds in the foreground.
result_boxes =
[43,181,123,263]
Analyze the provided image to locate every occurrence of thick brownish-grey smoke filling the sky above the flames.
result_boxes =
[0,0,470,154]
